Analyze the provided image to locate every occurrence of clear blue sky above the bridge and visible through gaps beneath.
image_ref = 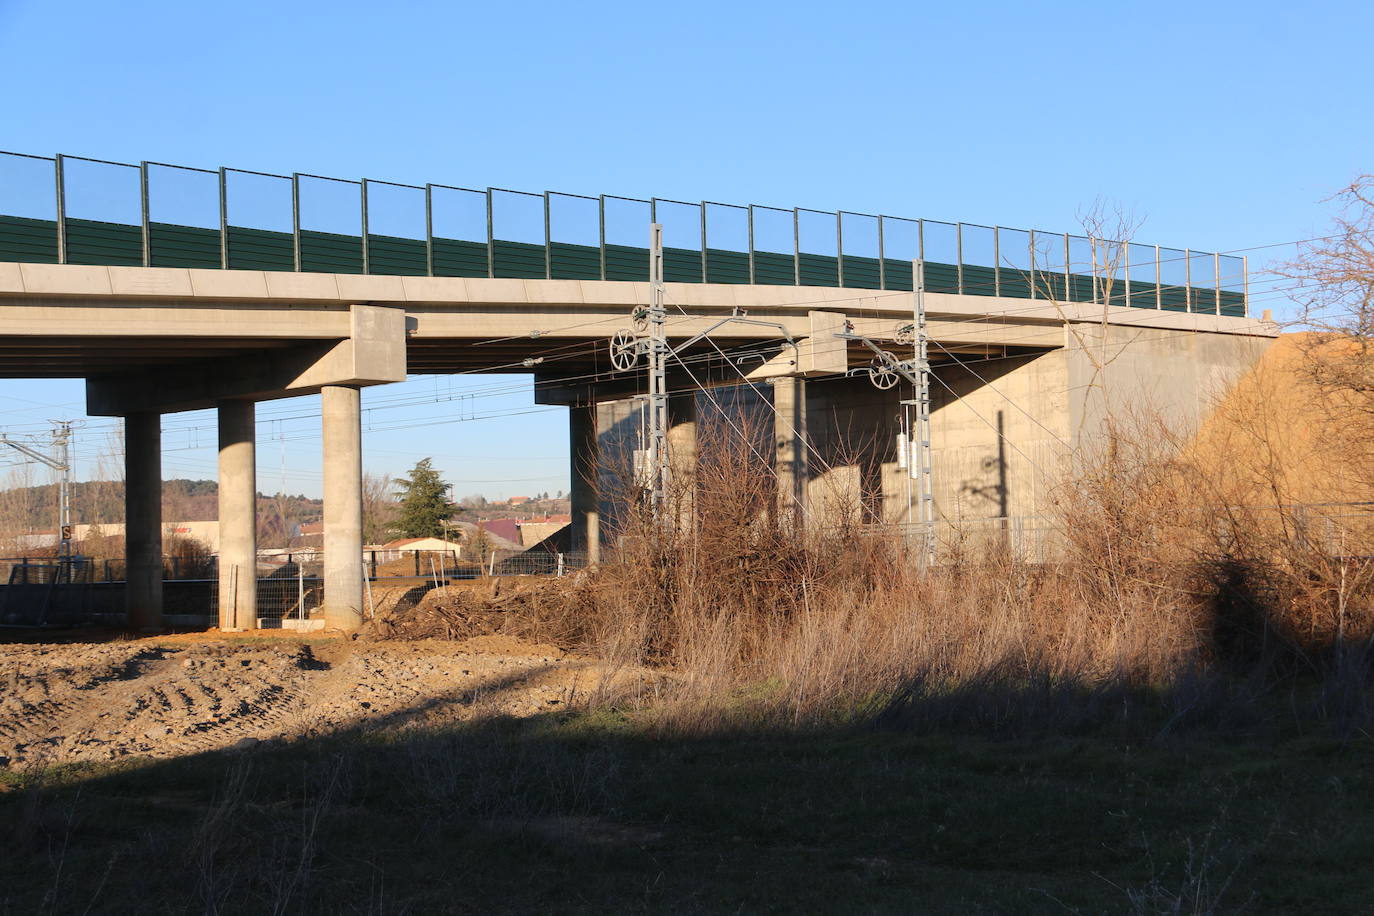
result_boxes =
[0,0,1374,496]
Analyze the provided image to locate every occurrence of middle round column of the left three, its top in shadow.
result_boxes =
[218,401,257,630]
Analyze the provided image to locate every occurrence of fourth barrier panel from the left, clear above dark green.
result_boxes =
[224,169,295,271]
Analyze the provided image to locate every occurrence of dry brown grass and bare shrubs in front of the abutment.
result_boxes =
[368,409,1374,733]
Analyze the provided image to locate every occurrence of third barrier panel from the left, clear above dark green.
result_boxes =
[148,165,224,268]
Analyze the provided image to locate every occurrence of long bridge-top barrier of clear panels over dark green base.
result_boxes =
[0,152,1248,316]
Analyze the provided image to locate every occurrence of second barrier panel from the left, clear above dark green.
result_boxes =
[62,157,143,266]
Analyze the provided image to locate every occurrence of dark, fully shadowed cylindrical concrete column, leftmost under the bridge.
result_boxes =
[124,412,162,632]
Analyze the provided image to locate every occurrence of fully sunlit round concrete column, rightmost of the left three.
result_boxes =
[320,385,363,633]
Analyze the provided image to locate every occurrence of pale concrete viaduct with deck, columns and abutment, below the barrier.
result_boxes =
[0,262,1276,630]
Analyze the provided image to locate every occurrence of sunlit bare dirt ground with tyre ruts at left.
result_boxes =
[0,630,653,769]
